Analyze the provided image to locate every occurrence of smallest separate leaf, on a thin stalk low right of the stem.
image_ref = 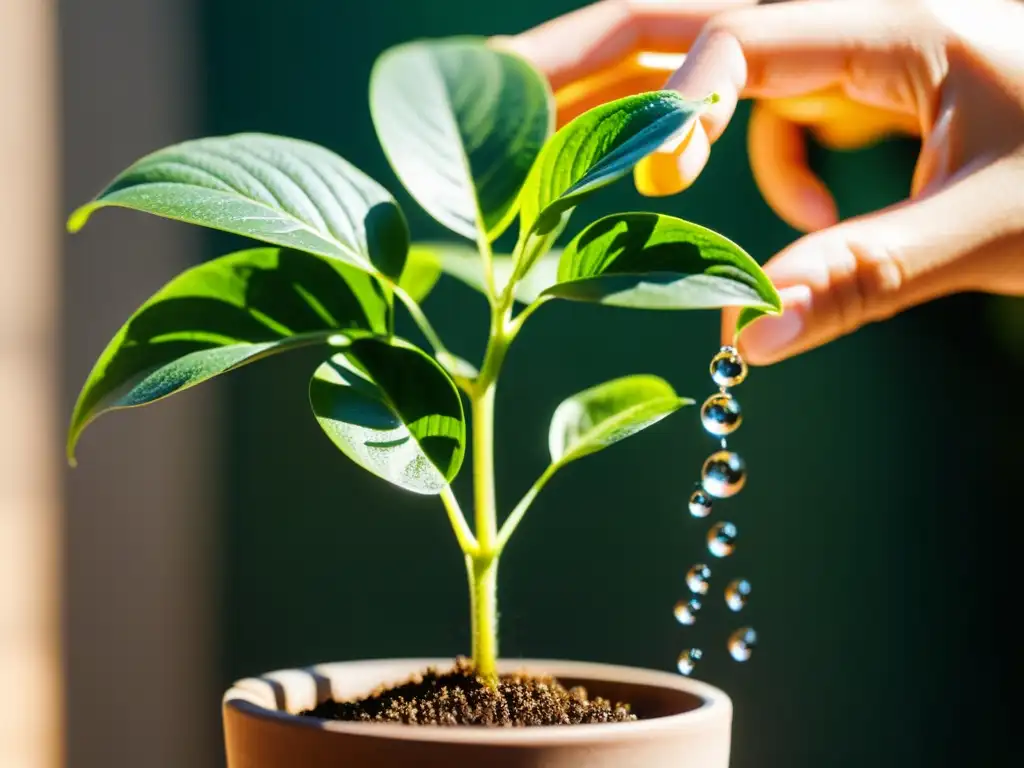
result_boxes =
[548,375,693,467]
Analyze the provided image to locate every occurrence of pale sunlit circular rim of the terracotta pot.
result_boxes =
[223,658,732,746]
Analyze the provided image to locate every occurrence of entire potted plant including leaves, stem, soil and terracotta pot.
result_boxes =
[68,38,780,768]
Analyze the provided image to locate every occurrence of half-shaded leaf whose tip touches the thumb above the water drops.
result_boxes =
[545,213,781,314]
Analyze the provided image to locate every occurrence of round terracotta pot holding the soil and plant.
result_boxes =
[223,658,732,768]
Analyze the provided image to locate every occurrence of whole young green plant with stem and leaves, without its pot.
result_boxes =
[68,38,780,680]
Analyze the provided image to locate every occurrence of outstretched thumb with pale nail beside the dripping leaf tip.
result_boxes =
[722,160,1020,365]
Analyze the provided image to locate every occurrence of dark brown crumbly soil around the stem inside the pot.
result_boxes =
[301,658,637,727]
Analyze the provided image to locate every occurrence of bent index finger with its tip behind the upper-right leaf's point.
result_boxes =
[640,0,942,194]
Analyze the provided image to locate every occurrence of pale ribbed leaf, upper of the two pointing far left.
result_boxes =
[68,133,409,278]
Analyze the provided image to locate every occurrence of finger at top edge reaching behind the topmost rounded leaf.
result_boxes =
[494,0,756,90]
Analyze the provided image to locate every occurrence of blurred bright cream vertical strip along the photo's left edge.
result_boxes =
[0,0,62,768]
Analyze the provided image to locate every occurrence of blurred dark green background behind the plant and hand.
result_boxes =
[202,0,1024,768]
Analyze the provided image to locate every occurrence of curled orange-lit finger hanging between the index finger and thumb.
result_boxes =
[748,102,839,232]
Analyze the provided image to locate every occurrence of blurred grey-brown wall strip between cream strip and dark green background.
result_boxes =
[60,0,221,768]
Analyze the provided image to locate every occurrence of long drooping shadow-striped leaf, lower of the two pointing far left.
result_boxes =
[68,248,389,463]
